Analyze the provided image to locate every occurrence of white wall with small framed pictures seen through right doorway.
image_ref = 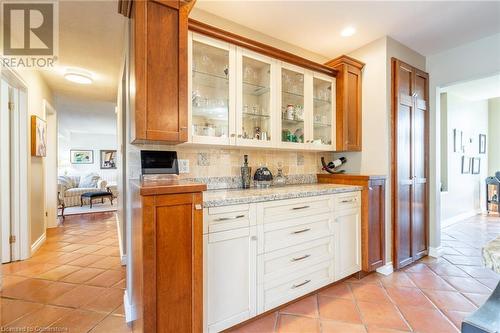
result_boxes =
[441,92,488,226]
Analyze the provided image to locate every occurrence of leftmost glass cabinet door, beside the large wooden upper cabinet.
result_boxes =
[191,38,231,143]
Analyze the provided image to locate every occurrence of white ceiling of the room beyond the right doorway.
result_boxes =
[441,74,500,101]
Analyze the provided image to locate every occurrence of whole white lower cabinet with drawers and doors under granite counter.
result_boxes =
[203,192,361,332]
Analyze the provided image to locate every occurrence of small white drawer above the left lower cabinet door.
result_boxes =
[203,204,255,233]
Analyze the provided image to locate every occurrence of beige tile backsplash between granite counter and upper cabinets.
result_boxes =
[128,145,333,183]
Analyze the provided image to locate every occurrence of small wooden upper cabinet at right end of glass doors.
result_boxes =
[325,55,364,151]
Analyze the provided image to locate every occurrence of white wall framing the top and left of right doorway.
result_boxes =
[426,34,500,248]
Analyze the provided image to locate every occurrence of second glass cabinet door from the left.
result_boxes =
[237,49,273,146]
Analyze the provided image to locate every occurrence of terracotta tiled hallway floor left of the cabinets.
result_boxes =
[0,213,131,333]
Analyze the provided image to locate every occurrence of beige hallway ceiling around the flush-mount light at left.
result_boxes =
[42,1,126,101]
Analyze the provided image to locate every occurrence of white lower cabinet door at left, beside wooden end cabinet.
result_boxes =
[204,227,257,332]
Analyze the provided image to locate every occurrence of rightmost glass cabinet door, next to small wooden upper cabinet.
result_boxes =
[309,73,335,151]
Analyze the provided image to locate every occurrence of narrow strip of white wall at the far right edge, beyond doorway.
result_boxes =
[487,97,500,176]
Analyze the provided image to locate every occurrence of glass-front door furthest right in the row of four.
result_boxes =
[311,77,334,146]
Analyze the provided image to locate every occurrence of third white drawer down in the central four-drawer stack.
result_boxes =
[258,236,335,283]
